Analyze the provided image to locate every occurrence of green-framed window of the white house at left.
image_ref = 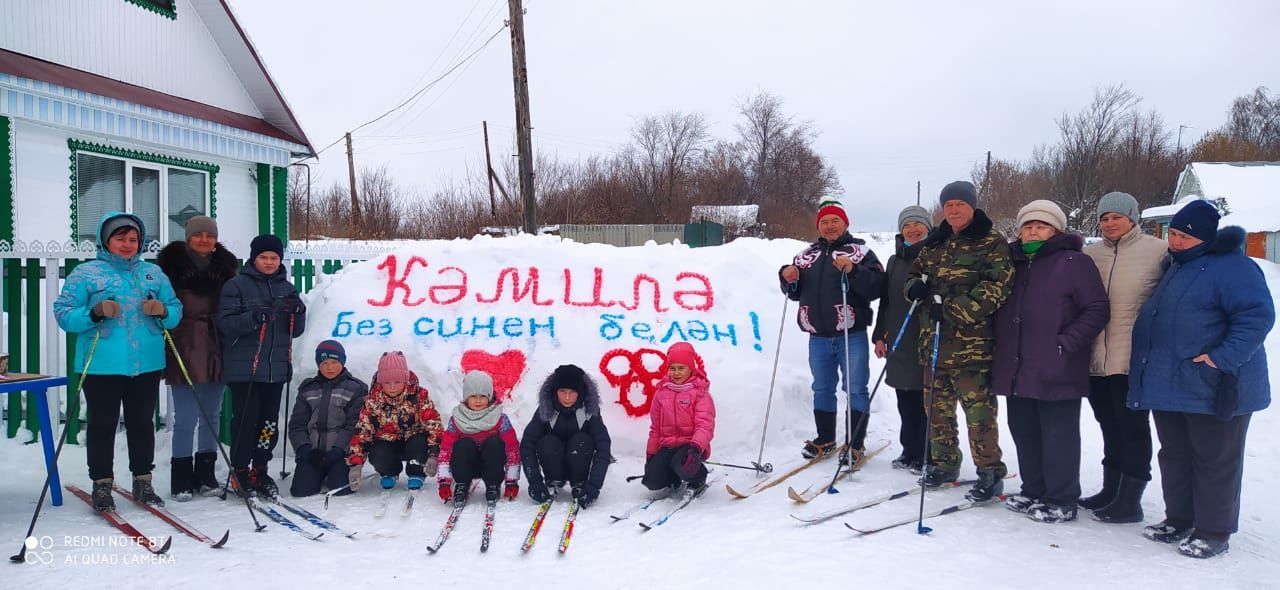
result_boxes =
[69,140,218,248]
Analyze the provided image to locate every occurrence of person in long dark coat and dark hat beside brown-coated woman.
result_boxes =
[218,234,307,498]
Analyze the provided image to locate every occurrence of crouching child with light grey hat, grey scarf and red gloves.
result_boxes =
[438,371,520,503]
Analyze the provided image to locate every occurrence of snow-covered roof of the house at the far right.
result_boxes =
[1142,161,1280,232]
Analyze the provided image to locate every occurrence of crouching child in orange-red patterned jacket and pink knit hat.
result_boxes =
[347,351,440,490]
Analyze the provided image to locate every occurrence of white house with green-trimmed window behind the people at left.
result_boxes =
[0,0,315,256]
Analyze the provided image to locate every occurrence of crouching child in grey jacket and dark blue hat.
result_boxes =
[289,340,369,498]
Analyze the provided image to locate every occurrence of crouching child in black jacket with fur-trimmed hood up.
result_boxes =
[520,365,611,508]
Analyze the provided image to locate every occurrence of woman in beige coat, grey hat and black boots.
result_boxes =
[1080,192,1169,522]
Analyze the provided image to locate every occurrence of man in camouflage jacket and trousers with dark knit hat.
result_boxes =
[904,180,1014,502]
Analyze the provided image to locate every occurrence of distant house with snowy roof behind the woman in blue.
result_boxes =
[1142,161,1280,262]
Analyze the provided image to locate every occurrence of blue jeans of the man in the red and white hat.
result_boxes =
[809,330,870,412]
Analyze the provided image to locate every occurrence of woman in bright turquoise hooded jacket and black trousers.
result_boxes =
[54,211,182,511]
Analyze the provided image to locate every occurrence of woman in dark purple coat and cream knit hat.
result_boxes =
[992,201,1111,522]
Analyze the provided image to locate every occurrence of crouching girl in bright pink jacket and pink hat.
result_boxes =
[641,342,716,493]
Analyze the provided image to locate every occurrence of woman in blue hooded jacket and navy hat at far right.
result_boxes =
[1128,200,1275,558]
